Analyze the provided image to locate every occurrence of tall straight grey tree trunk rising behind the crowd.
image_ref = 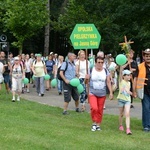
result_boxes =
[44,0,50,55]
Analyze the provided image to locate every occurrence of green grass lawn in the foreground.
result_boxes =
[0,87,150,150]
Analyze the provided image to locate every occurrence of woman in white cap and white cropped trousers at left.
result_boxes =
[11,57,25,102]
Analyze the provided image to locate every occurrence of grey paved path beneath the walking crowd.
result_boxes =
[21,87,142,119]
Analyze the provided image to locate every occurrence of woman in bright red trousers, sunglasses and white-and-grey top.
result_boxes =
[89,57,113,131]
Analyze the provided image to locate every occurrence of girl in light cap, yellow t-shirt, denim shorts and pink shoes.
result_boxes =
[117,68,132,135]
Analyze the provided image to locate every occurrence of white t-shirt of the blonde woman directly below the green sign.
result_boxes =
[75,60,90,78]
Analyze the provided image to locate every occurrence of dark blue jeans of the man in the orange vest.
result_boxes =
[142,94,150,129]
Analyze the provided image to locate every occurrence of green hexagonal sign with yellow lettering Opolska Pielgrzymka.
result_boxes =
[70,24,101,49]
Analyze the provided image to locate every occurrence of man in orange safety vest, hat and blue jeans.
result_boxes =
[134,48,150,132]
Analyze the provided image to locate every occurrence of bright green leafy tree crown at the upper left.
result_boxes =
[4,0,49,53]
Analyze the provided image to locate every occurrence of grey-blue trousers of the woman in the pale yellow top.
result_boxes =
[34,76,45,94]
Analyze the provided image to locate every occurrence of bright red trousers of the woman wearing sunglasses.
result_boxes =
[89,94,106,123]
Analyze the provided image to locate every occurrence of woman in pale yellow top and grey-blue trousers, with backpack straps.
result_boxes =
[32,54,47,96]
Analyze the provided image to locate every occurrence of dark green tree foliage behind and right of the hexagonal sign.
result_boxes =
[53,0,150,54]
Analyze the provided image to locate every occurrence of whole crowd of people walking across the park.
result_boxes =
[0,49,150,135]
